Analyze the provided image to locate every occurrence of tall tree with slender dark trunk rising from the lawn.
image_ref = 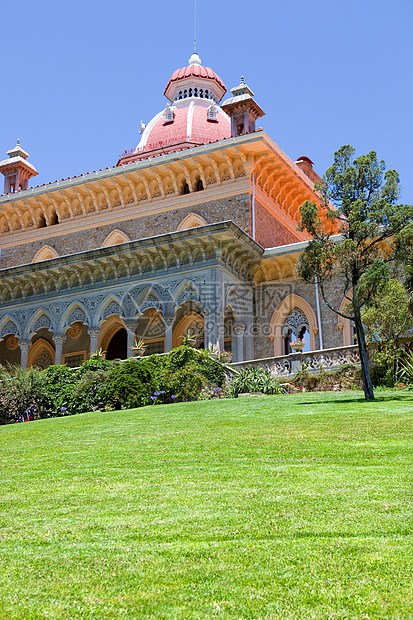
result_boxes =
[298,145,413,400]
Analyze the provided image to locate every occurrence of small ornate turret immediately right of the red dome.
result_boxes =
[221,76,265,137]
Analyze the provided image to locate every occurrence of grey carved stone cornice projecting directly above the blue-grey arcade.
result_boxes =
[0,222,264,304]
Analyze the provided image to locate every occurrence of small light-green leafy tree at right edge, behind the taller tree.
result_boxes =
[361,278,412,385]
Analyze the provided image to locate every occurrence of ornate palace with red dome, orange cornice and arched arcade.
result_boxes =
[0,53,352,368]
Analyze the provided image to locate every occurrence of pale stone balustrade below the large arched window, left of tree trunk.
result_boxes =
[231,345,360,378]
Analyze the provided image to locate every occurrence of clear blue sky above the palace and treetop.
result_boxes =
[0,0,413,203]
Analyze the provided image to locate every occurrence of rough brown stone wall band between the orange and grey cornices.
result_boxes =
[0,193,250,269]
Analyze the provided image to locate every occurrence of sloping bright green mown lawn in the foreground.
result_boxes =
[0,392,413,620]
